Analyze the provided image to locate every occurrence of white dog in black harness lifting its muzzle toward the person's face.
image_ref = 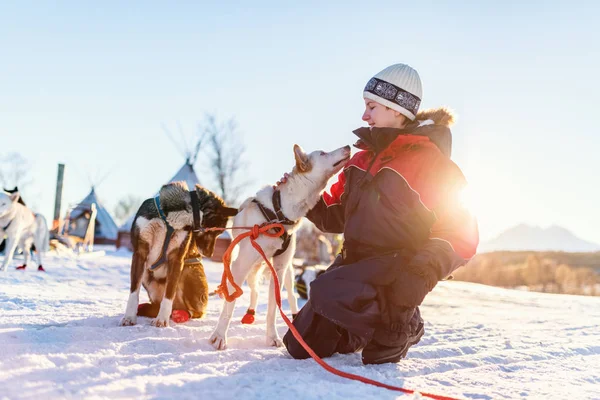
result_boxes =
[209,145,350,350]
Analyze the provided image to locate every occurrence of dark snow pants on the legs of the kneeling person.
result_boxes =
[283,252,430,364]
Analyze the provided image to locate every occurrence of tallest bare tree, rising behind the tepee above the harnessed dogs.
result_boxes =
[199,114,248,205]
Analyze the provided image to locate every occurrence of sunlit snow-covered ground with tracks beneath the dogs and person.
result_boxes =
[0,251,600,399]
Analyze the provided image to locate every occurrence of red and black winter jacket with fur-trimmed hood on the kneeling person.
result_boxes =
[307,109,479,289]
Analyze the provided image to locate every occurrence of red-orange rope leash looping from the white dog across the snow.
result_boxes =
[206,223,458,400]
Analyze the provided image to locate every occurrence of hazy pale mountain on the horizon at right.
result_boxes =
[477,224,600,253]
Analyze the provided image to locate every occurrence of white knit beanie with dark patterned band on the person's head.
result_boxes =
[363,64,423,121]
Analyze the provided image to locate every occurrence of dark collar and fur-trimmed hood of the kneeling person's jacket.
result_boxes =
[354,107,455,158]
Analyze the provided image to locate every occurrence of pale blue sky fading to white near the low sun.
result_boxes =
[0,1,600,242]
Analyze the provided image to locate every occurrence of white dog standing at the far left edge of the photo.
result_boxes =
[0,191,50,271]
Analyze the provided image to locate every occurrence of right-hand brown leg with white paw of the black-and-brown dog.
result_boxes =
[151,232,192,328]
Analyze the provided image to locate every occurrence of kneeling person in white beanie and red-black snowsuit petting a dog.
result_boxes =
[283,64,479,364]
